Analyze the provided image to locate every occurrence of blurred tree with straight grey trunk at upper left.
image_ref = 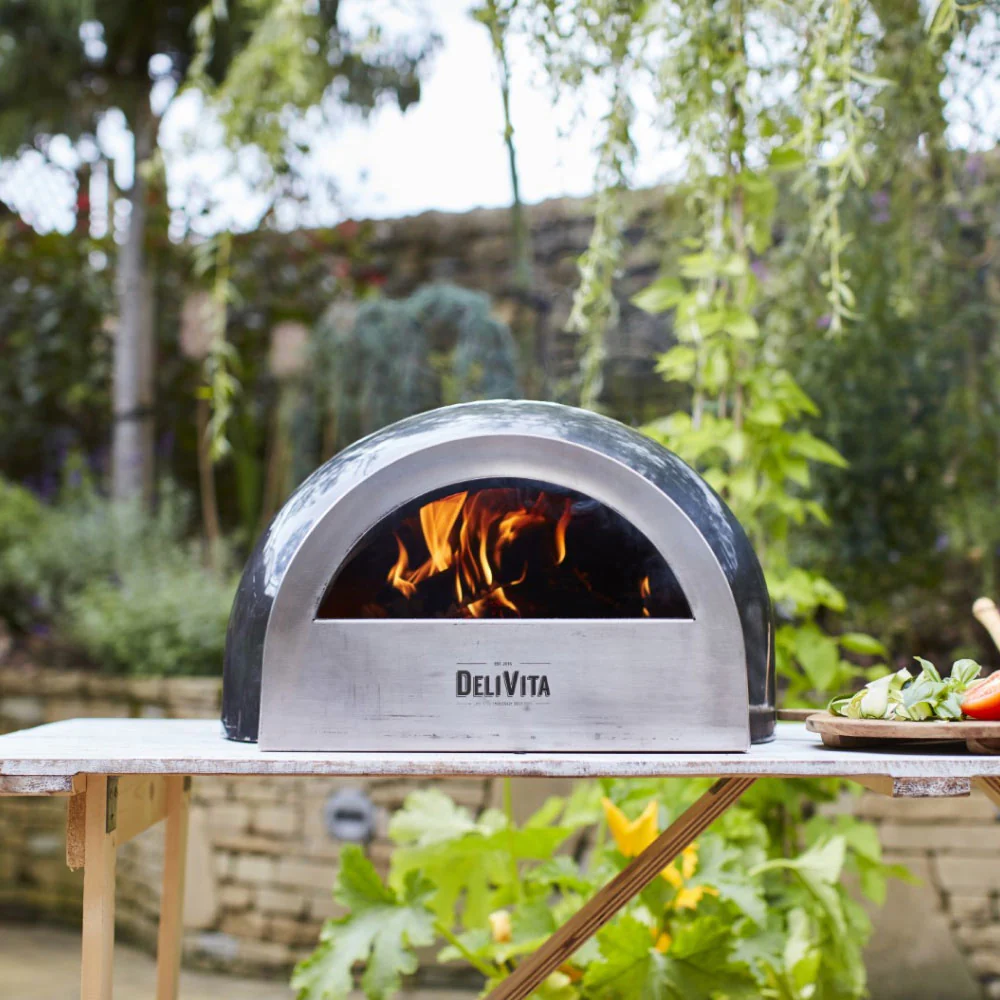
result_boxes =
[0,0,436,508]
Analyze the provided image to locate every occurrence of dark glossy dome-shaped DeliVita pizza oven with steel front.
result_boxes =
[223,401,775,751]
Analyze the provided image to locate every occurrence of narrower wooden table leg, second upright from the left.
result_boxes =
[156,776,191,1000]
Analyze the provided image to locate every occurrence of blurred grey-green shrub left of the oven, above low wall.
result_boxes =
[0,479,236,674]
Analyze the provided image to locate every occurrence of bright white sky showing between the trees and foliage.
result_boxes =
[0,0,997,235]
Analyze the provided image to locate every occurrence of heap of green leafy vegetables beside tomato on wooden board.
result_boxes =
[830,656,984,722]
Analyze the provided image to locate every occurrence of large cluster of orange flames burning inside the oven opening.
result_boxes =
[386,489,572,618]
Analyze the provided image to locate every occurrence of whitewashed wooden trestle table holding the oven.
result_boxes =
[0,719,1000,1000]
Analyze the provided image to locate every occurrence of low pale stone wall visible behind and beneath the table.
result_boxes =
[0,667,1000,1000]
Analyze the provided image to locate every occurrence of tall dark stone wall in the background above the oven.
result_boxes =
[370,190,677,425]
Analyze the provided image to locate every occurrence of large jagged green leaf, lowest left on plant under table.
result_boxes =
[292,844,435,1000]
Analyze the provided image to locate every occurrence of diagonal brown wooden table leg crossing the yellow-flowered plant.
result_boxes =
[486,778,756,1000]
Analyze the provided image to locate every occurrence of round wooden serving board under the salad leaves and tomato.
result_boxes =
[806,712,1000,754]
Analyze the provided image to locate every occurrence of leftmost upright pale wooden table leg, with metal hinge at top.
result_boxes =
[80,775,117,1000]
